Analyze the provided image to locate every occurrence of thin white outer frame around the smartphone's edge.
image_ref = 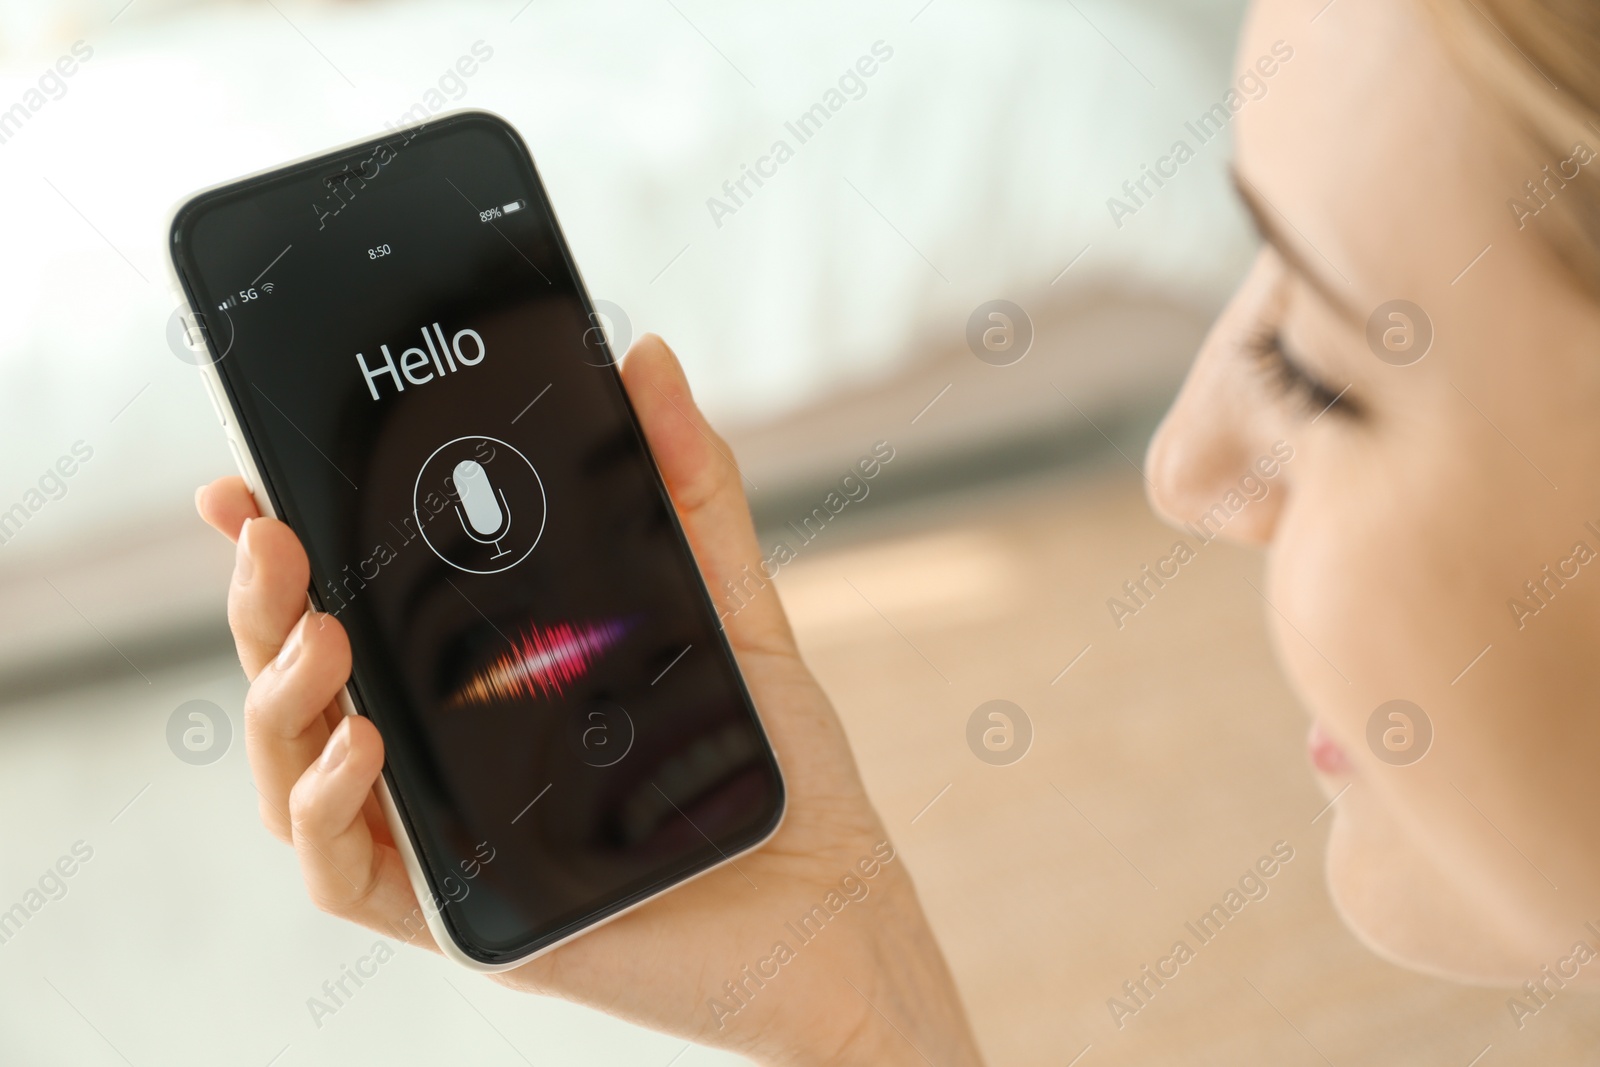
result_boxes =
[162,107,789,974]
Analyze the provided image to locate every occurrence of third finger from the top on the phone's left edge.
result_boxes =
[245,611,350,841]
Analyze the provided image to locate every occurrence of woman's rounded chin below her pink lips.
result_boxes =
[1326,790,1539,987]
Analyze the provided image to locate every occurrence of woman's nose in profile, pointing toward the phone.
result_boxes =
[1144,255,1293,544]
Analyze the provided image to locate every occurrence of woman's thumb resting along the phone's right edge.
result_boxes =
[622,334,795,653]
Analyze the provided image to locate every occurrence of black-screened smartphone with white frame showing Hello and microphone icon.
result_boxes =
[170,110,784,971]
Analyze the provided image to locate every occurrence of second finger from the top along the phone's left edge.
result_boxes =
[227,518,310,678]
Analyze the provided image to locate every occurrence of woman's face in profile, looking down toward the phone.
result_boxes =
[1149,0,1600,984]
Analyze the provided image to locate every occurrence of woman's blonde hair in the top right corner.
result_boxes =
[1426,0,1600,299]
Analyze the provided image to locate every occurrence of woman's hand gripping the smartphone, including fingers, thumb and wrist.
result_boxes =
[195,336,979,1065]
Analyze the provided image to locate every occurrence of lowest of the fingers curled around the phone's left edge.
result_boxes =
[290,717,437,950]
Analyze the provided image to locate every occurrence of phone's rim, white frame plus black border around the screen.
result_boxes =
[166,109,789,973]
